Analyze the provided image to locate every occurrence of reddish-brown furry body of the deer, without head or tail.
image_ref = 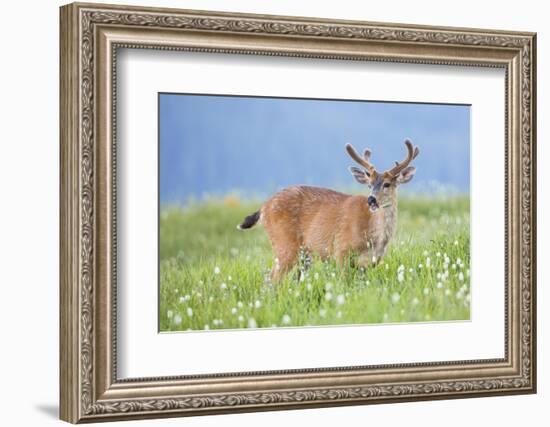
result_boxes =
[260,186,397,281]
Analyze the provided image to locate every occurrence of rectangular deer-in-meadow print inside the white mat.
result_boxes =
[158,93,471,332]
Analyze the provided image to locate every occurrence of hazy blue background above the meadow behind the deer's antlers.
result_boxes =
[159,94,470,203]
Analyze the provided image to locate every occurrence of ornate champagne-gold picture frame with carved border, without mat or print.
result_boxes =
[60,3,536,423]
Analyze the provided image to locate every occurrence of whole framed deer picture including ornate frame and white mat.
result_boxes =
[60,4,536,423]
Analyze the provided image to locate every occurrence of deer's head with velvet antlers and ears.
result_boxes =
[346,139,420,212]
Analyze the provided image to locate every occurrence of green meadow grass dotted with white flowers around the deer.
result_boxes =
[160,196,470,331]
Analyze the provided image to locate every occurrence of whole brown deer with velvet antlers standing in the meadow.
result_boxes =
[237,139,420,283]
